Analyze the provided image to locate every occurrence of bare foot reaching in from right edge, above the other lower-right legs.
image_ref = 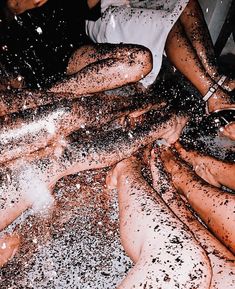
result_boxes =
[175,142,235,190]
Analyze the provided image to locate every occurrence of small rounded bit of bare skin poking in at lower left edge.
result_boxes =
[0,234,20,267]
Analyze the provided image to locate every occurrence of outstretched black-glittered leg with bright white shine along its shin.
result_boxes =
[0,94,160,163]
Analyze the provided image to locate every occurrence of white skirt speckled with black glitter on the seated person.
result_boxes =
[86,0,188,86]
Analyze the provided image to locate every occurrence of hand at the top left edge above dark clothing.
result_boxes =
[7,0,48,15]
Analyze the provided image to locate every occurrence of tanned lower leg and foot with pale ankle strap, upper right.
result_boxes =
[166,21,235,140]
